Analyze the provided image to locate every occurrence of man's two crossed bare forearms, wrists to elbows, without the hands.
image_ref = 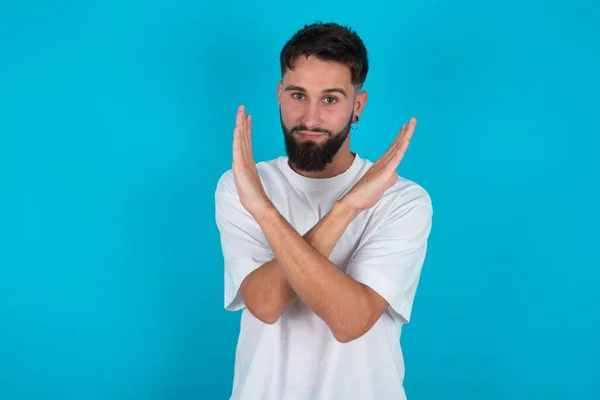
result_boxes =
[241,197,388,343]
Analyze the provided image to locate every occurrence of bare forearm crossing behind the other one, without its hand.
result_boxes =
[240,202,358,324]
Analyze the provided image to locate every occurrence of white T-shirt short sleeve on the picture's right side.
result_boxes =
[346,186,433,323]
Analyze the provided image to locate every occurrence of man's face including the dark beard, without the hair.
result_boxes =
[278,57,355,172]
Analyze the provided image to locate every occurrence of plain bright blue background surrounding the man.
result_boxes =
[0,0,600,400]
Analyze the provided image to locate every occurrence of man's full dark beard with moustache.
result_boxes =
[279,111,352,172]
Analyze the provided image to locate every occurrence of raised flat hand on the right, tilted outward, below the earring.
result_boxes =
[342,117,417,212]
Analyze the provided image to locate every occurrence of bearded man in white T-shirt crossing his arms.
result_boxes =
[215,23,432,400]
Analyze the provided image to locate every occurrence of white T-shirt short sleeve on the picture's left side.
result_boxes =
[215,170,274,311]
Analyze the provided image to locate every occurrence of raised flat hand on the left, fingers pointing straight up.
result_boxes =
[232,106,271,215]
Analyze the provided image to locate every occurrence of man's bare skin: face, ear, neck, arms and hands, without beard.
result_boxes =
[232,57,416,343]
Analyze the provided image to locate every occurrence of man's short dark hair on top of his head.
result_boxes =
[279,22,369,86]
